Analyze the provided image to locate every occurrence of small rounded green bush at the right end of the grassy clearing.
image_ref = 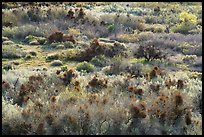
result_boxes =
[76,61,94,73]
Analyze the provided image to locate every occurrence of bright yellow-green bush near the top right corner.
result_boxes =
[172,12,197,34]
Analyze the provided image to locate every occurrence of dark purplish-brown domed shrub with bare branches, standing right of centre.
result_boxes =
[134,45,165,61]
